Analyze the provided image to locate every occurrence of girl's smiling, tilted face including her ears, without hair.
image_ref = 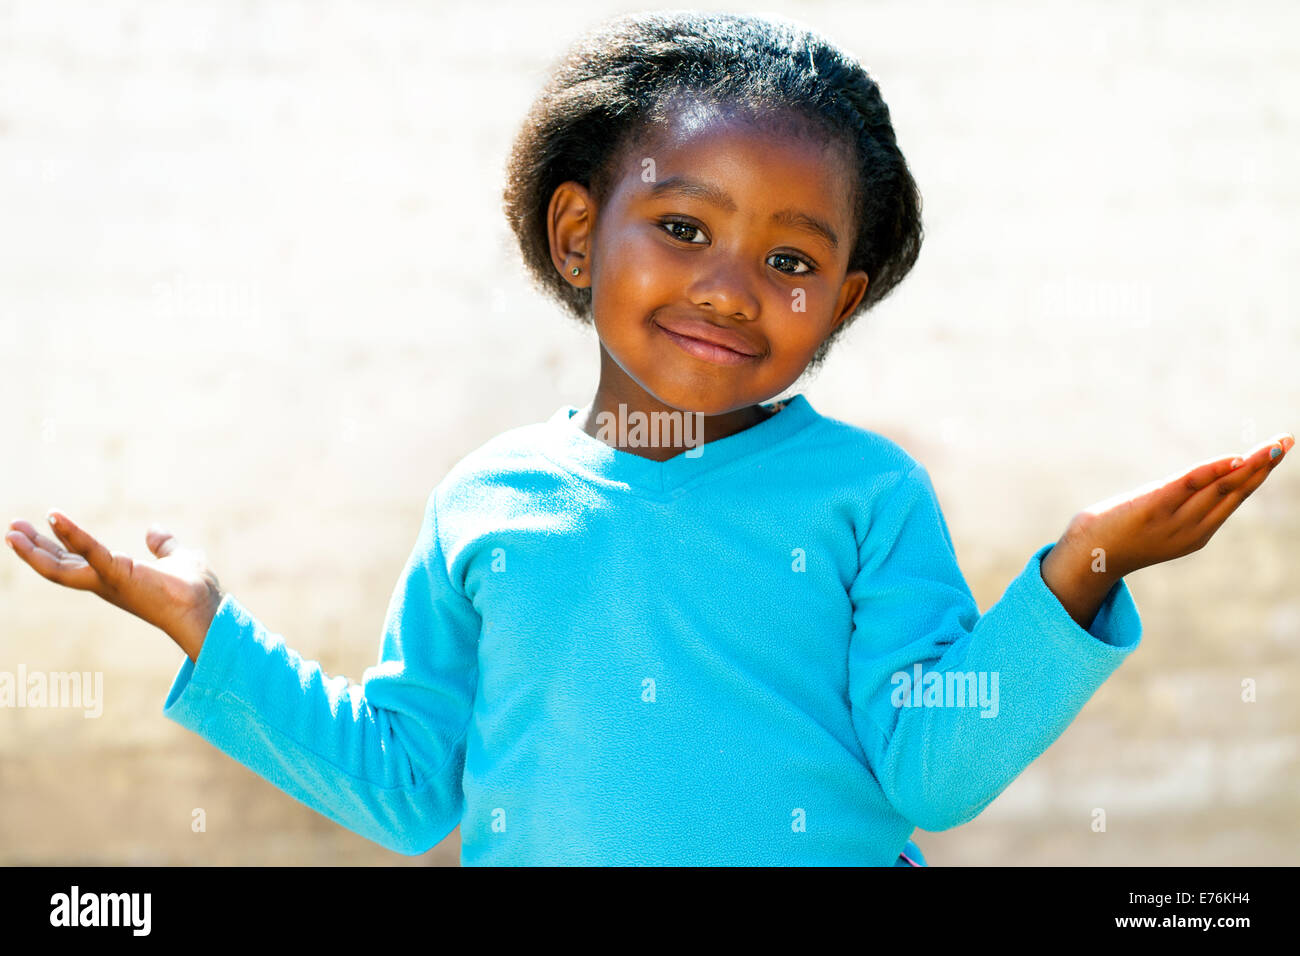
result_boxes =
[549,112,867,415]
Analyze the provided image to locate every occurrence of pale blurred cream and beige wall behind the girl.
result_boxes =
[0,0,1300,865]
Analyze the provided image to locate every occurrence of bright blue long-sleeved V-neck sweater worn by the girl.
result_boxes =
[163,394,1141,865]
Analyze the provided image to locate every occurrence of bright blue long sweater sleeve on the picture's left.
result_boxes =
[163,489,480,855]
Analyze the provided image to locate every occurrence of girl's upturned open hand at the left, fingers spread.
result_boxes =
[4,511,222,662]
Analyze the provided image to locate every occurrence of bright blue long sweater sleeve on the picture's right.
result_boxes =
[849,464,1141,831]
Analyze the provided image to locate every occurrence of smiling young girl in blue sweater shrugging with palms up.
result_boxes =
[5,13,1294,865]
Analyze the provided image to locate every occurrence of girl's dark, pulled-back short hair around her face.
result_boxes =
[504,10,922,368]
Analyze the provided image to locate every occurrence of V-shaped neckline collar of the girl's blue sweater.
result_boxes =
[542,393,820,498]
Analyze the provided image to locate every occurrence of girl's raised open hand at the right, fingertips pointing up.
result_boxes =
[1048,433,1296,581]
